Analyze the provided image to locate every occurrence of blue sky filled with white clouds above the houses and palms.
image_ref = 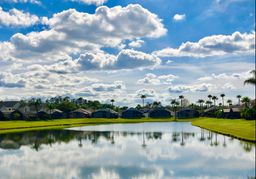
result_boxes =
[0,0,255,106]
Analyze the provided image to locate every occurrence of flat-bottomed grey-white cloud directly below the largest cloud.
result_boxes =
[78,49,161,70]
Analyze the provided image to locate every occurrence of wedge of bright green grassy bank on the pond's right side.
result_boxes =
[192,118,256,141]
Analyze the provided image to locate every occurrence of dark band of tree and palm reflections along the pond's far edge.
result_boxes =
[0,129,255,152]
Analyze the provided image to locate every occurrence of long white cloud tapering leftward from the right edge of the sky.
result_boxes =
[153,32,255,58]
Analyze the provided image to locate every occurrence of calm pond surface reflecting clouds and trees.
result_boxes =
[0,123,255,179]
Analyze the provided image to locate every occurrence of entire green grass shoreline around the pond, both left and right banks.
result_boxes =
[0,117,256,142]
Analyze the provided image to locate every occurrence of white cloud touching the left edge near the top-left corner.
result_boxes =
[0,7,40,27]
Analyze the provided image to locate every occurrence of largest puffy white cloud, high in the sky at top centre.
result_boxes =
[45,4,167,46]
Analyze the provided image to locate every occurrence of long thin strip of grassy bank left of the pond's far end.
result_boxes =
[0,118,176,134]
